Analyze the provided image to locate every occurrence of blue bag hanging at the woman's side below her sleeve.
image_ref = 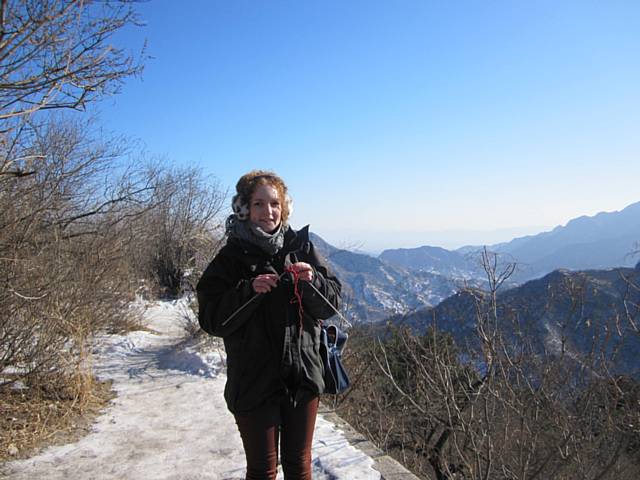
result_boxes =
[320,324,351,395]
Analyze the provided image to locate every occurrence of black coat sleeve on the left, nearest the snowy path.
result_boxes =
[196,252,263,337]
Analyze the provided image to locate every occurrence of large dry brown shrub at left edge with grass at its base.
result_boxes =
[0,117,149,462]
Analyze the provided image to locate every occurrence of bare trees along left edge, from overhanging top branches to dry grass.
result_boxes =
[0,0,155,457]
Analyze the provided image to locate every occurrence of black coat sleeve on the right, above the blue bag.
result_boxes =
[302,242,342,320]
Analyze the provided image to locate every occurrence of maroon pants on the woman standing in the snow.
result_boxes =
[236,397,319,480]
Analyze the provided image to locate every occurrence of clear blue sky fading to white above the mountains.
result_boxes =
[99,0,640,251]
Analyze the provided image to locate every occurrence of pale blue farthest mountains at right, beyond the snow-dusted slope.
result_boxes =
[379,202,640,283]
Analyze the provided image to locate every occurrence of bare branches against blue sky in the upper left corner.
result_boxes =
[0,0,142,124]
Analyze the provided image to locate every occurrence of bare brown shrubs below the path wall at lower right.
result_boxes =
[338,251,640,480]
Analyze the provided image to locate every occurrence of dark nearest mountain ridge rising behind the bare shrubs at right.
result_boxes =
[392,262,640,375]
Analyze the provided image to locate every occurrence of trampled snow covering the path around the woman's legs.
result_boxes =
[0,300,380,480]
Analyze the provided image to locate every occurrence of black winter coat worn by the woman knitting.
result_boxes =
[197,226,341,414]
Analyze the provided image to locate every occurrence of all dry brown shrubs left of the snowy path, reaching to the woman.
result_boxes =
[0,116,221,462]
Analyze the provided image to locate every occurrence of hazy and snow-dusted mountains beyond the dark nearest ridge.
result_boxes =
[312,202,640,322]
